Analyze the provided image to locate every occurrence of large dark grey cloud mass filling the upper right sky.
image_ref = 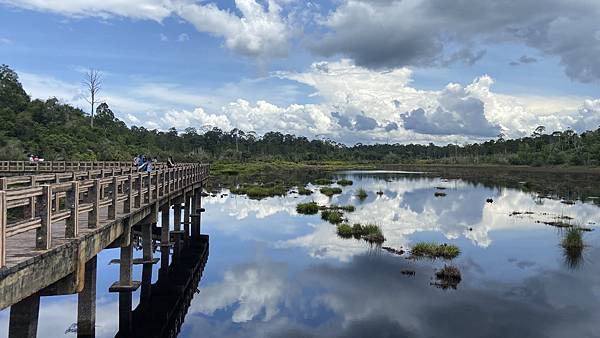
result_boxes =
[313,0,600,82]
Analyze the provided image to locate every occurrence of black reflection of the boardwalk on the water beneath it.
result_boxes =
[116,235,208,338]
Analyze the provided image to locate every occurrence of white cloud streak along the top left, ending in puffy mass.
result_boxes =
[0,0,294,59]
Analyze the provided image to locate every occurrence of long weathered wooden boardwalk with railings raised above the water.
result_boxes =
[0,162,209,309]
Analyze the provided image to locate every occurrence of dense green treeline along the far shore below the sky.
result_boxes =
[0,66,600,166]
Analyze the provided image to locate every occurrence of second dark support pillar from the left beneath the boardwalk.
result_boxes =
[77,256,97,338]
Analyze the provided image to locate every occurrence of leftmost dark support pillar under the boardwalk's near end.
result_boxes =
[8,293,40,338]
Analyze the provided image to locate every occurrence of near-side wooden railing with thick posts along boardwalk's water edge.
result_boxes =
[0,162,209,267]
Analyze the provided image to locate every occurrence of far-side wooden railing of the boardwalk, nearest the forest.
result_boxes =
[0,161,182,173]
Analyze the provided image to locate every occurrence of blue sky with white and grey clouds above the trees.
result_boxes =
[0,0,600,144]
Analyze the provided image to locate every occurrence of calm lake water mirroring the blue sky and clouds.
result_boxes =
[0,172,600,337]
